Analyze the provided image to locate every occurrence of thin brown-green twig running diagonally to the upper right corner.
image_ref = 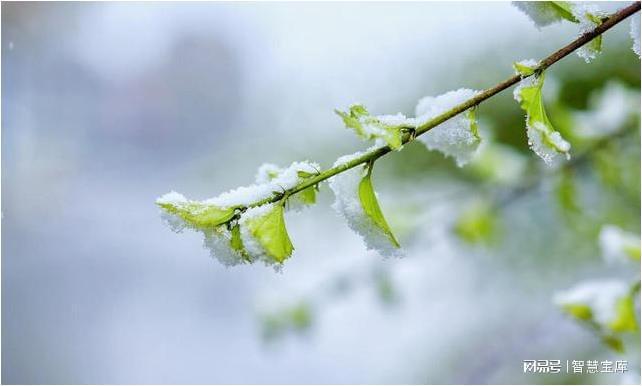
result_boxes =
[248,2,640,207]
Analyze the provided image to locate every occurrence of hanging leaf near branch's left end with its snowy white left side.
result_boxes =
[239,202,294,264]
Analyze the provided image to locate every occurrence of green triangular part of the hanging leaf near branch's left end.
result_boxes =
[246,203,294,263]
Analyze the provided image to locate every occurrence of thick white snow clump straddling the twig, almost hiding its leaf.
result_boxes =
[415,88,480,167]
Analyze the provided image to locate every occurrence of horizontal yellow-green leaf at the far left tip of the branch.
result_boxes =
[157,201,234,230]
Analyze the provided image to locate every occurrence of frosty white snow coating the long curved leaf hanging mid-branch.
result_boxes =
[329,152,402,257]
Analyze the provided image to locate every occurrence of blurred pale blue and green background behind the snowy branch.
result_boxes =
[2,2,640,384]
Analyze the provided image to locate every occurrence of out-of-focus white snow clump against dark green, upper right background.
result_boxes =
[573,81,640,138]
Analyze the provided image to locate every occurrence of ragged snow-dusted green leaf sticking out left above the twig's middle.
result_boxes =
[335,104,415,150]
